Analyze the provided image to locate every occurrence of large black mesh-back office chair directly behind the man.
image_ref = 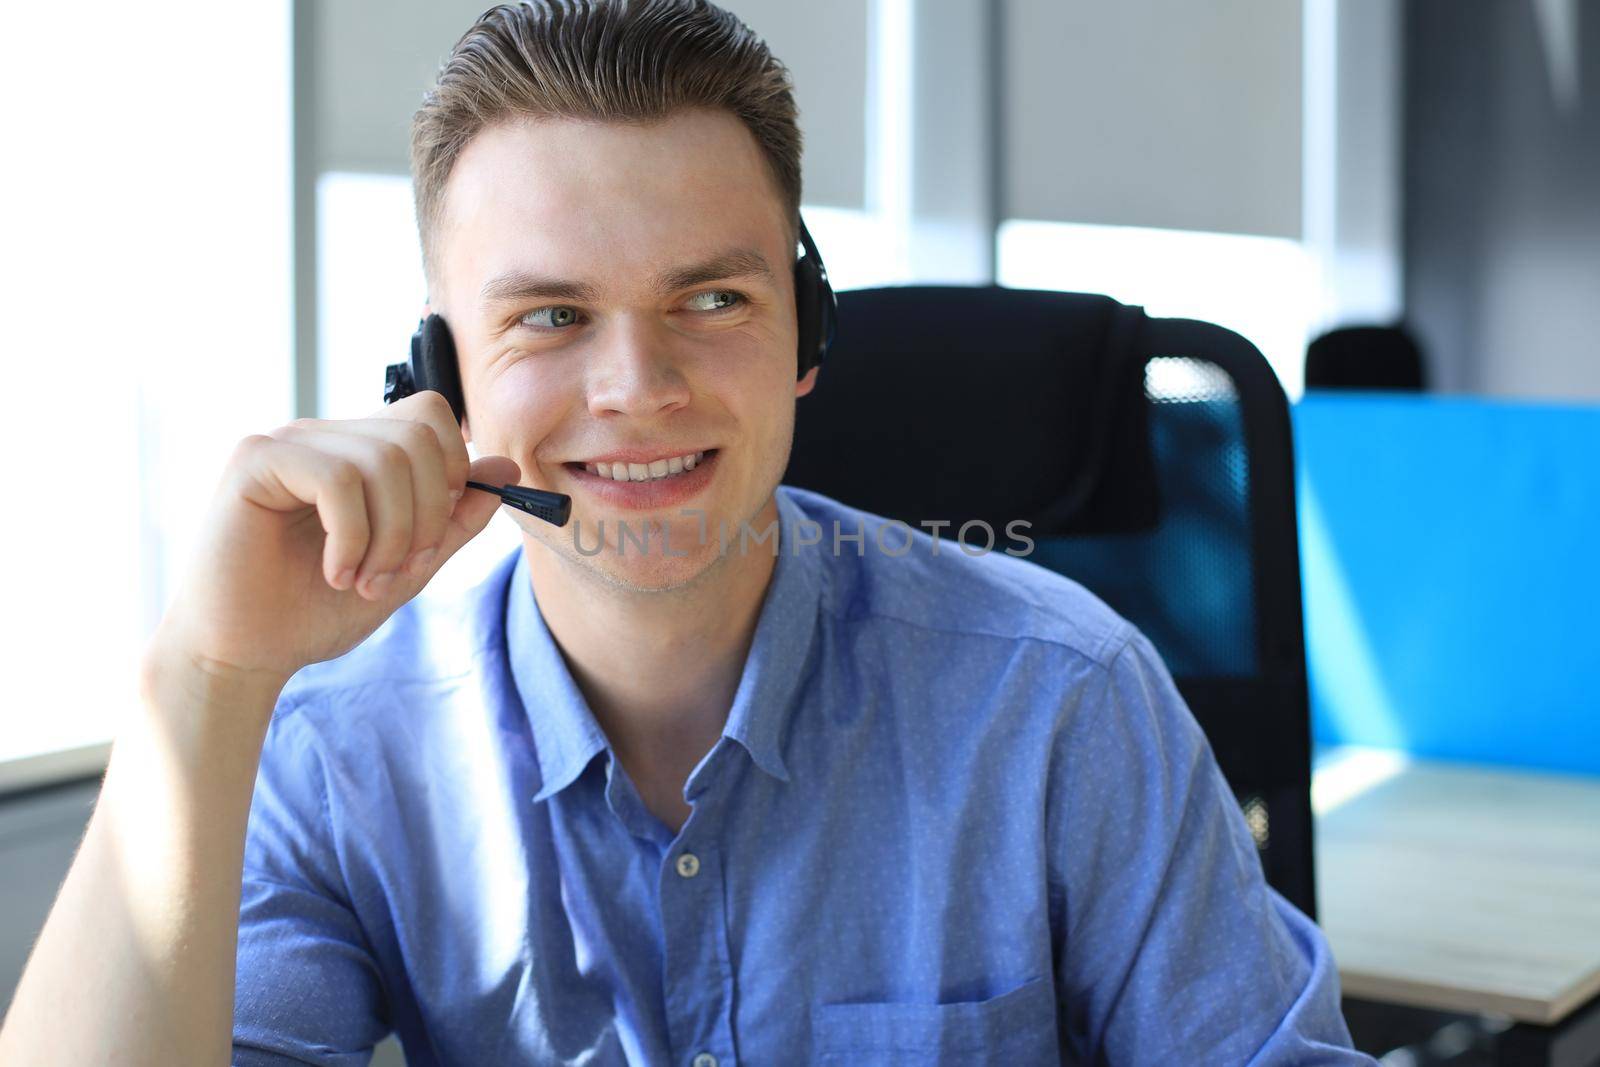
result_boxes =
[784,286,1315,917]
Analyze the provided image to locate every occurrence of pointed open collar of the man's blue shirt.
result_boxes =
[506,486,830,801]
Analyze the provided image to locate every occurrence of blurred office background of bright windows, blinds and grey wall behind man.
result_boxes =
[0,0,1600,1062]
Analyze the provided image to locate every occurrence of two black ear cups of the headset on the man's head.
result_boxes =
[384,212,838,422]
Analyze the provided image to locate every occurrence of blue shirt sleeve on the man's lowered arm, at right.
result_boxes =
[1048,629,1376,1067]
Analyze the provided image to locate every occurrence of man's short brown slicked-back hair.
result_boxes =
[411,0,800,287]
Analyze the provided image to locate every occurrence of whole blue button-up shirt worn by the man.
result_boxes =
[234,486,1373,1067]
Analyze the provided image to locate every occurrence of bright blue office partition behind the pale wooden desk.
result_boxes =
[1293,392,1600,774]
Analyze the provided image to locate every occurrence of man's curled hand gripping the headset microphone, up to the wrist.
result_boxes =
[147,392,520,694]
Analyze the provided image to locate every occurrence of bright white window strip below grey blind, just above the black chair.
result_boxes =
[997,219,1322,402]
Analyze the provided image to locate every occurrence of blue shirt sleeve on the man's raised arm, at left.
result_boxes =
[234,705,390,1067]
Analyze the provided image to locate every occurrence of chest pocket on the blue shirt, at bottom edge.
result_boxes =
[811,977,1061,1067]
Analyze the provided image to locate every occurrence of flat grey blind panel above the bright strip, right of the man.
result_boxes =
[1002,0,1301,237]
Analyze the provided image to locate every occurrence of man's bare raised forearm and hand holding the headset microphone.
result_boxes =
[0,392,518,1067]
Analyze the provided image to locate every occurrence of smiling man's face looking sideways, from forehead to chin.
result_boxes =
[434,110,816,589]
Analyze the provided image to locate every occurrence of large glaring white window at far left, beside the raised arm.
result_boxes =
[0,0,293,785]
